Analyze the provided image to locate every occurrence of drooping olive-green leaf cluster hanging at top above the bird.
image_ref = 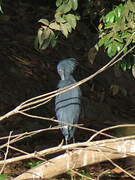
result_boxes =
[35,0,80,50]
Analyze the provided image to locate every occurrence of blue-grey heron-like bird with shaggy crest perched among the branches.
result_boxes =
[55,58,82,144]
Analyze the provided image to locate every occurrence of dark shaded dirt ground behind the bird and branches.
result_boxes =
[0,0,135,179]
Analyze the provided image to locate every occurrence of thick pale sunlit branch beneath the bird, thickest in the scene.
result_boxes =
[14,138,135,180]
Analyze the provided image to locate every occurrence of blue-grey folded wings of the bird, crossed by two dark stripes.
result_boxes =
[55,84,81,124]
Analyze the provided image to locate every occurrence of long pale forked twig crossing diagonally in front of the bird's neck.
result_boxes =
[0,33,135,121]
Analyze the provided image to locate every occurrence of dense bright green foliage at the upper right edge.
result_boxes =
[96,0,135,74]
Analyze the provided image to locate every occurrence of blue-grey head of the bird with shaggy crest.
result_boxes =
[57,58,77,80]
